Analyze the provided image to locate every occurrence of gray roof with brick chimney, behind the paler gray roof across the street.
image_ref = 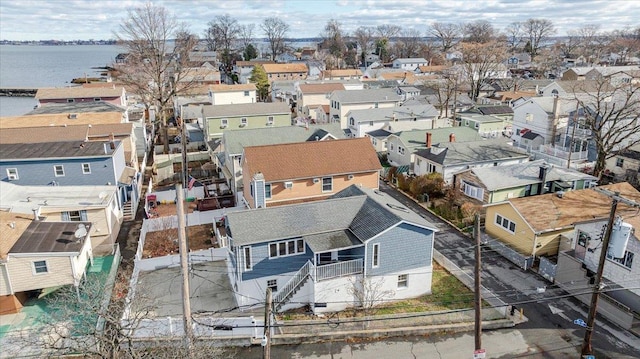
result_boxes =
[416,138,529,166]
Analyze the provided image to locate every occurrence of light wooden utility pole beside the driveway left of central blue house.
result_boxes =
[175,183,193,357]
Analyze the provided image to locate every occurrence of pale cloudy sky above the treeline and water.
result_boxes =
[0,0,640,40]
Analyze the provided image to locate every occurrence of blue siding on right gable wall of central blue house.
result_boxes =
[365,223,433,276]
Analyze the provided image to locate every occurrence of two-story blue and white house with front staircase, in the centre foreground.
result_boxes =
[224,185,436,313]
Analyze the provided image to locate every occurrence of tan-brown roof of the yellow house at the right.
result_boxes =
[509,182,640,232]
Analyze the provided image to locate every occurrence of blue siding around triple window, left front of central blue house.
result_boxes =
[236,243,313,284]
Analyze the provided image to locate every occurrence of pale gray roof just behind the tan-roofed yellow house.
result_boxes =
[471,160,597,191]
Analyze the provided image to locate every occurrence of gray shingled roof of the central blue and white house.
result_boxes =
[227,185,436,246]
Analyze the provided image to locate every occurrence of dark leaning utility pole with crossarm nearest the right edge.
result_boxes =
[581,188,640,355]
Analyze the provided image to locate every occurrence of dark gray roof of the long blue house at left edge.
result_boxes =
[0,141,120,161]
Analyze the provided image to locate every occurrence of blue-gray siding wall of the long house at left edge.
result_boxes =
[0,158,117,186]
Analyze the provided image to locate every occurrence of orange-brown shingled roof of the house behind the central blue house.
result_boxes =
[243,138,382,181]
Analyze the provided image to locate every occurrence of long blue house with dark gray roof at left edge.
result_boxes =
[0,141,141,212]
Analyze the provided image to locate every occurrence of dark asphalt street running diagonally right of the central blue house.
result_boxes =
[380,183,640,358]
